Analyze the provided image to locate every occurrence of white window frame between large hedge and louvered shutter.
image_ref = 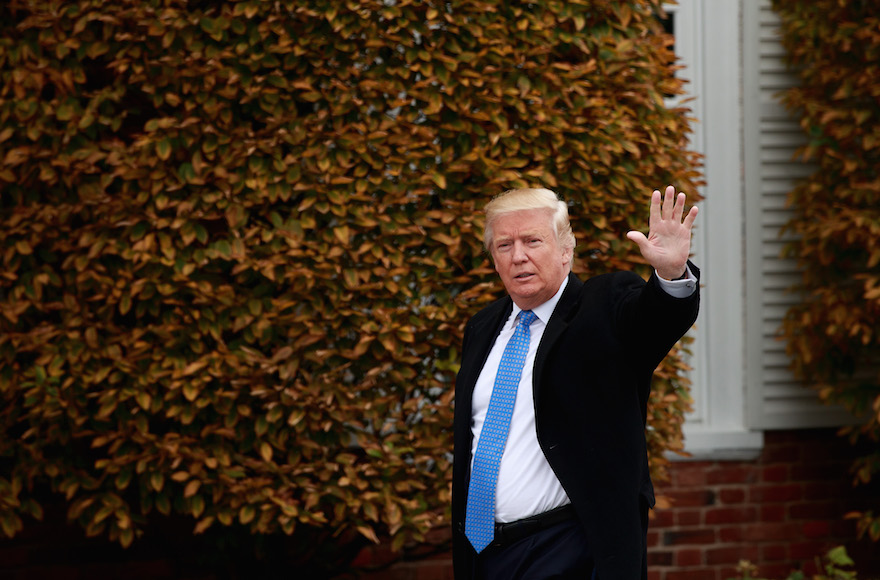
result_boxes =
[667,0,764,460]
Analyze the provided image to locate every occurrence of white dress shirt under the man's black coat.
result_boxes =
[471,268,697,523]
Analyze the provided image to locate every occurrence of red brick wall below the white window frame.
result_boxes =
[361,429,880,580]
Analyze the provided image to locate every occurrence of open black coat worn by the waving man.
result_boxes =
[452,264,699,580]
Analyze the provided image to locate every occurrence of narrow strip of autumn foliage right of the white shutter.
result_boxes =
[774,0,880,540]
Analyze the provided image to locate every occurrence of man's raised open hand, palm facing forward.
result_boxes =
[626,185,698,280]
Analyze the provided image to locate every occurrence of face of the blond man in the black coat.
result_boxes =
[489,209,572,310]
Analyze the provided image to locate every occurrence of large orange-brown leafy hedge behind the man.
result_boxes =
[0,0,697,572]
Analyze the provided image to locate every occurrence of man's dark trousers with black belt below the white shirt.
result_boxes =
[474,518,596,580]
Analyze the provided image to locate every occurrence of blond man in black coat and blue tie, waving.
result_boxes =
[452,186,699,580]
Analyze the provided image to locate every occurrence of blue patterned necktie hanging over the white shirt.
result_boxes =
[464,310,537,553]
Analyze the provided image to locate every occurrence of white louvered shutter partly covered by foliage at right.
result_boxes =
[743,0,851,429]
